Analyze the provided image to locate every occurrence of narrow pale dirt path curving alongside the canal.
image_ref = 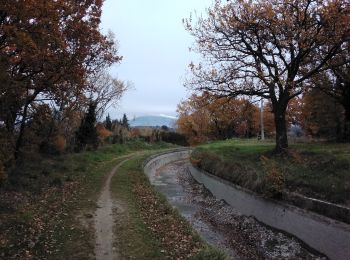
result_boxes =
[94,156,132,260]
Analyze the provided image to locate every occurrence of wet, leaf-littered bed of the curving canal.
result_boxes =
[152,160,325,260]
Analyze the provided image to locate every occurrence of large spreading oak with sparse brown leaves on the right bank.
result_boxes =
[185,0,350,152]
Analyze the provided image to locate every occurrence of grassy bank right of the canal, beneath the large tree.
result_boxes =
[192,139,350,206]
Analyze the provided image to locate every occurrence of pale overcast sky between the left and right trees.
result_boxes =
[101,0,212,119]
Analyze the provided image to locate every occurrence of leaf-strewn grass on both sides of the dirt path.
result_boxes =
[0,140,226,259]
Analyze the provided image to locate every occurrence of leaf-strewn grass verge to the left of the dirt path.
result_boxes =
[0,141,176,259]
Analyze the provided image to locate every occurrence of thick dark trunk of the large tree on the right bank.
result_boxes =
[274,107,288,153]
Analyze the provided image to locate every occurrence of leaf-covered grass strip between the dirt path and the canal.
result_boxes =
[112,156,226,260]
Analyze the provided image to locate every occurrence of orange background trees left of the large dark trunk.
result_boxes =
[177,92,274,144]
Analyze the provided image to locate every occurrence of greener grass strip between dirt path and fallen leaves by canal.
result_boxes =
[111,154,161,259]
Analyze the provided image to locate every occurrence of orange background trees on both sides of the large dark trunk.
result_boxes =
[177,88,346,144]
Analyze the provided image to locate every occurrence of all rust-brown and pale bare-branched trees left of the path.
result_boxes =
[0,0,126,166]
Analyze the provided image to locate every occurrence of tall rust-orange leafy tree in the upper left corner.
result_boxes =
[0,0,121,157]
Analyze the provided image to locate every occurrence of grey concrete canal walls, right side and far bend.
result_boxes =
[144,150,350,260]
